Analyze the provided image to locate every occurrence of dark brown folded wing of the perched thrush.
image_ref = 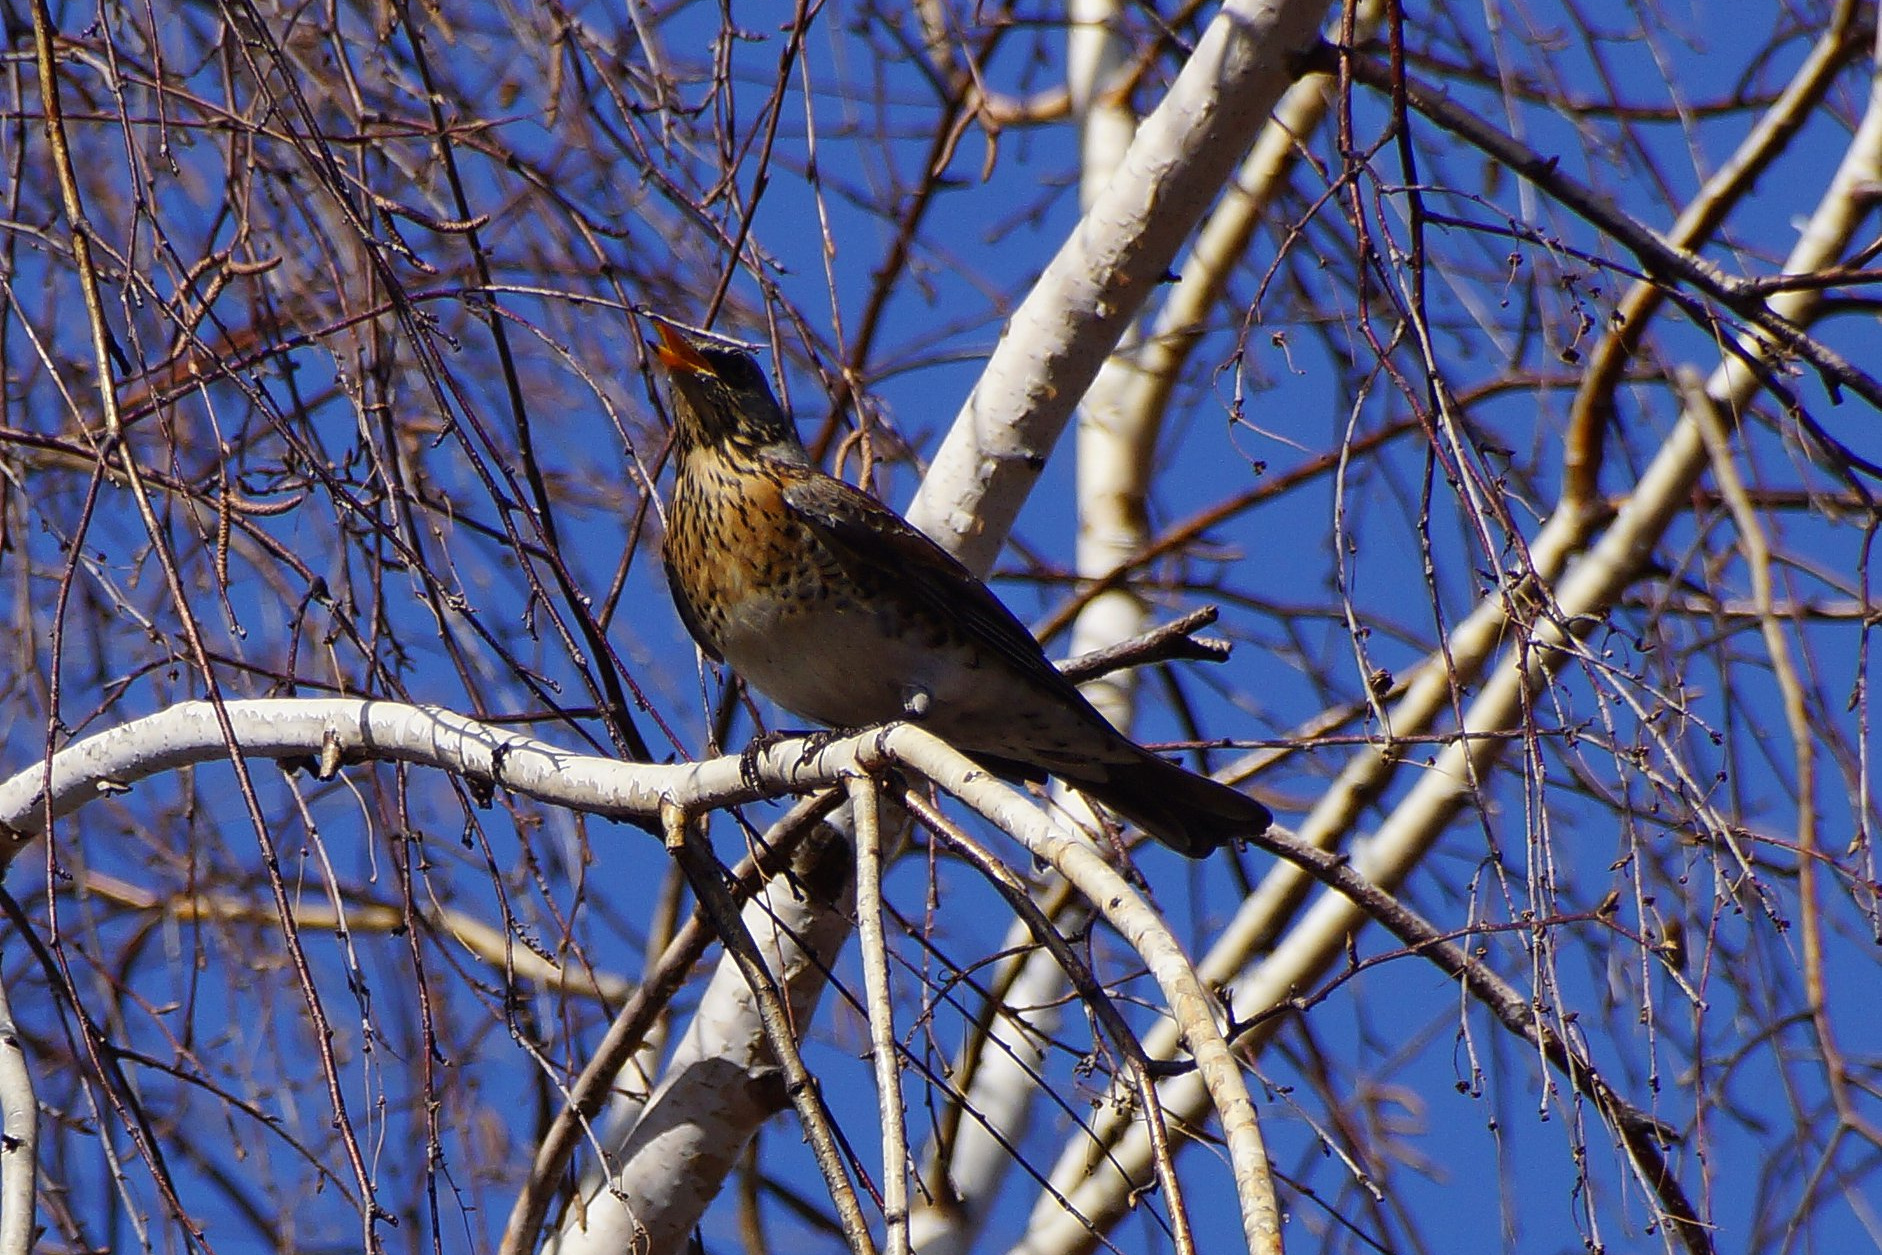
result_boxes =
[783,470,1084,704]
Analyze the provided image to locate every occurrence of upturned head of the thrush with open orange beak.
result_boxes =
[653,322,804,461]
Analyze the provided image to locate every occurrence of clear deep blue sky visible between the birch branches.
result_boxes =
[4,4,1882,1251]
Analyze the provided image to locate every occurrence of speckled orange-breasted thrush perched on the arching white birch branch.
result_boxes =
[649,322,1272,858]
